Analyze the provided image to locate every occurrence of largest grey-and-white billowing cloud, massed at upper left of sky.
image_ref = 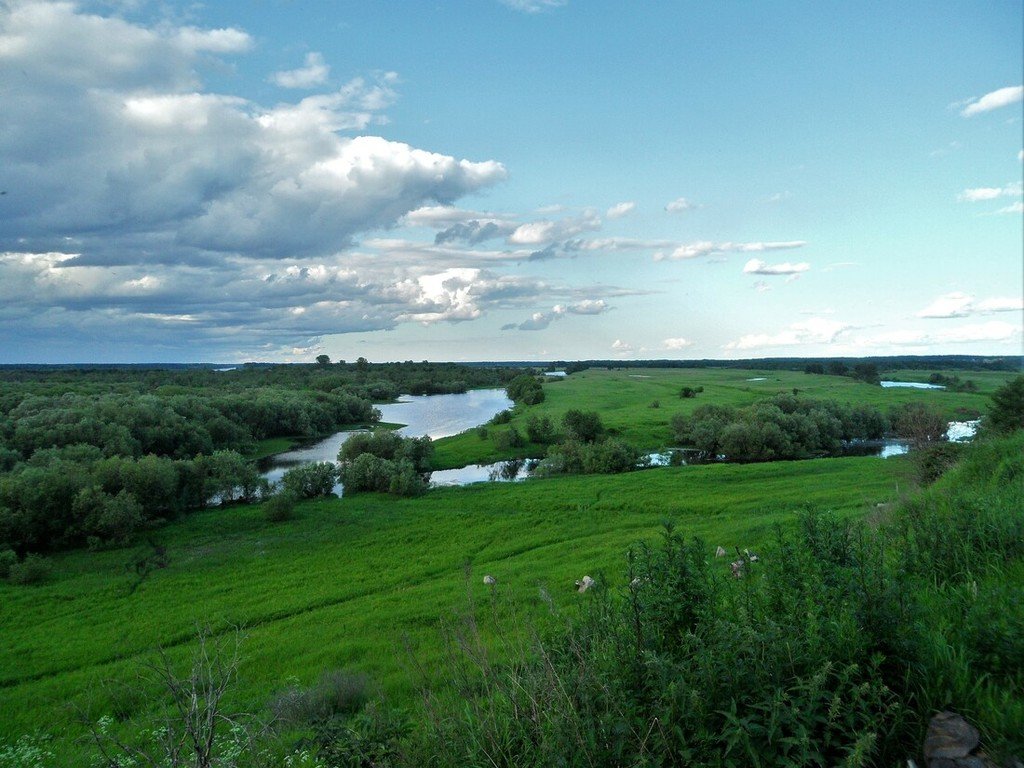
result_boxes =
[0,0,505,260]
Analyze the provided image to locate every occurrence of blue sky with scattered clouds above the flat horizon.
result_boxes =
[0,0,1024,364]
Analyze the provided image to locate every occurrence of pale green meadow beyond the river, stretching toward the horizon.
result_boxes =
[434,369,1016,469]
